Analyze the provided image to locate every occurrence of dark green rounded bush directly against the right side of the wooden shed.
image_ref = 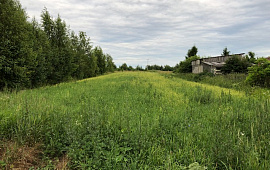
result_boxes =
[221,55,251,74]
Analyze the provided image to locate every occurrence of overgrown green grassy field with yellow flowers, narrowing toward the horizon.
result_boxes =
[0,72,270,169]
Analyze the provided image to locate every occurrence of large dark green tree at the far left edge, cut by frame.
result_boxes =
[0,0,36,90]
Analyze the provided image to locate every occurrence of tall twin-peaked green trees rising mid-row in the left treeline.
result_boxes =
[41,9,77,83]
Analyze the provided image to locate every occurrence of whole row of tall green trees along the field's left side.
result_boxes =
[0,0,116,90]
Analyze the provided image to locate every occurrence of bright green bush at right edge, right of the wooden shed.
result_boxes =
[246,58,270,87]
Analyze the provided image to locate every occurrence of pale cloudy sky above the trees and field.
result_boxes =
[20,0,270,67]
